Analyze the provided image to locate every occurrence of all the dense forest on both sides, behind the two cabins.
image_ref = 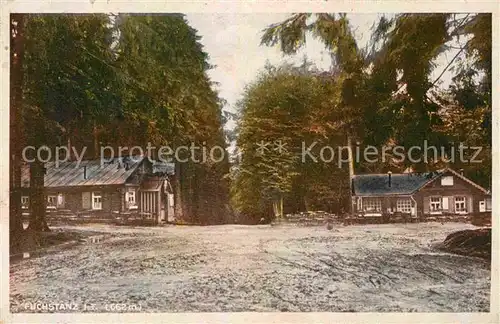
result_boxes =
[10,13,492,244]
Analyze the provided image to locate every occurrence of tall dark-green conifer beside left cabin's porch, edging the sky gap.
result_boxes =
[115,14,229,223]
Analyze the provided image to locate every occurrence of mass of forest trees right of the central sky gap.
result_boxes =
[231,13,492,224]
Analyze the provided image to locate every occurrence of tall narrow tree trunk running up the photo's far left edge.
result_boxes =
[9,14,24,250]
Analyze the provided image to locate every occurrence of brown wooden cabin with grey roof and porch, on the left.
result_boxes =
[21,156,174,224]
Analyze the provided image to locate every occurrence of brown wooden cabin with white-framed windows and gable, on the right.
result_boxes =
[352,168,492,219]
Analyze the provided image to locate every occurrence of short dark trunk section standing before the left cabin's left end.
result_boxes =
[28,161,50,232]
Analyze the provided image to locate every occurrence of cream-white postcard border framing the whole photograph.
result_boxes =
[0,0,500,323]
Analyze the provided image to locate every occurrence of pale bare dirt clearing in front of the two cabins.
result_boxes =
[10,223,490,312]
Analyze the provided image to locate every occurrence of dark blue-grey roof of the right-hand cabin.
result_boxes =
[353,172,442,196]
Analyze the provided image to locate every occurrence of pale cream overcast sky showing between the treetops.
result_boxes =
[186,13,454,127]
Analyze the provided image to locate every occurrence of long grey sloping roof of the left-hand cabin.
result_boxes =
[21,156,144,188]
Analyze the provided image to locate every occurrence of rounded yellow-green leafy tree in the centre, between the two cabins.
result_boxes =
[231,66,345,221]
